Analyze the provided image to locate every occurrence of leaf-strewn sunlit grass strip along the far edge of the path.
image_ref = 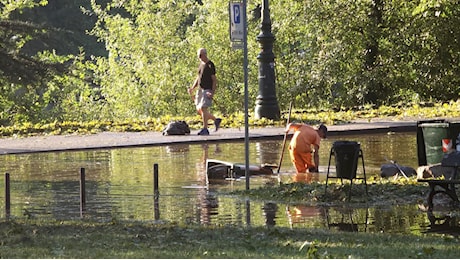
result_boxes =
[0,101,460,136]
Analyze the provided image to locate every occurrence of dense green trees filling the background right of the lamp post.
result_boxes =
[271,0,460,108]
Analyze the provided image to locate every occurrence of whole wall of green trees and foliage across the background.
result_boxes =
[0,0,460,125]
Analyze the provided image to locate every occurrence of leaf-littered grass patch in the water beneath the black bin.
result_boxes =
[233,177,429,205]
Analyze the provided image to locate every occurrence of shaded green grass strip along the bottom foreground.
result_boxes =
[0,218,460,259]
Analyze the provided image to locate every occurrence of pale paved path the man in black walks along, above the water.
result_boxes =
[0,119,430,154]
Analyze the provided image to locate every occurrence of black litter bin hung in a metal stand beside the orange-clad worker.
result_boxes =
[332,141,361,180]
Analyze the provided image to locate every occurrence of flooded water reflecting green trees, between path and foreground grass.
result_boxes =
[0,134,458,236]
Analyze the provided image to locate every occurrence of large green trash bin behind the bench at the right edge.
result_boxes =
[419,122,449,165]
